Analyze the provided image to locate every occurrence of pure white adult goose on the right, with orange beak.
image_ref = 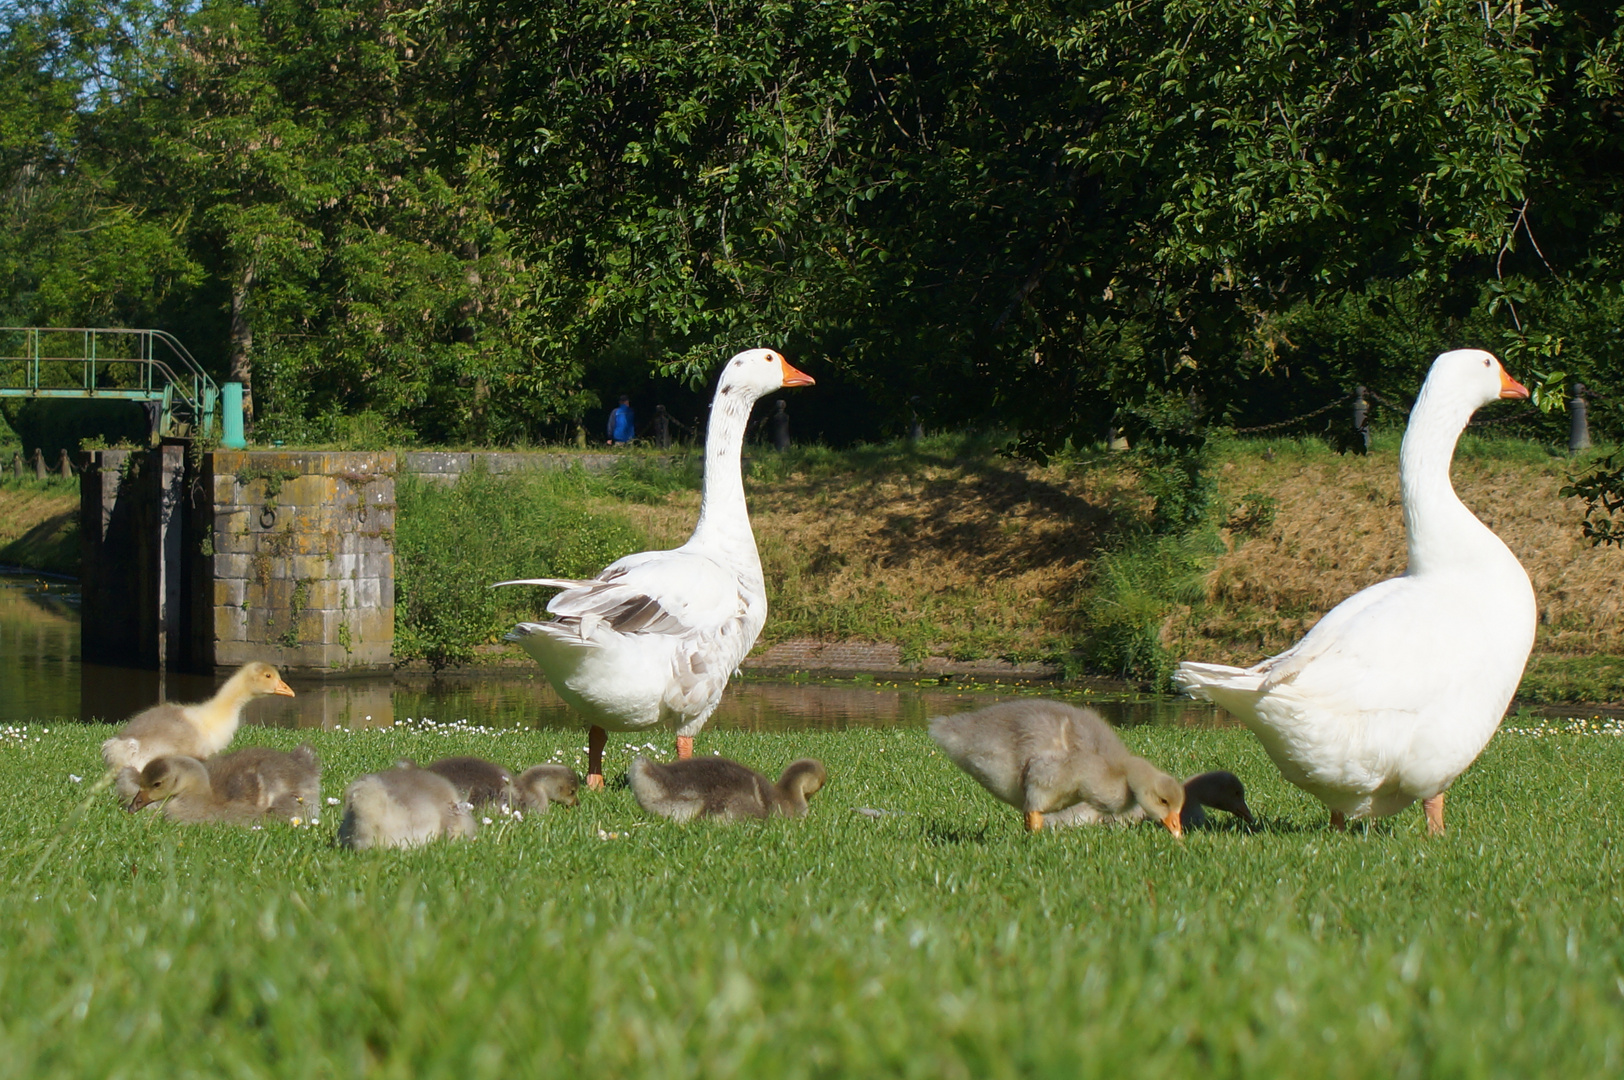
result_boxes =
[1173,349,1536,835]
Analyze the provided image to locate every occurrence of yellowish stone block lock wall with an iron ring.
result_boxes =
[203,450,396,672]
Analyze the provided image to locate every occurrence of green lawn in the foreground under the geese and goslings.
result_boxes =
[0,711,1624,1078]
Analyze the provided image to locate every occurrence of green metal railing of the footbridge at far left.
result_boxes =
[0,326,219,442]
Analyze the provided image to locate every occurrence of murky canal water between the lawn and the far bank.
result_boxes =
[0,573,1224,731]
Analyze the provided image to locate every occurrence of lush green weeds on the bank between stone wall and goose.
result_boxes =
[395,469,643,669]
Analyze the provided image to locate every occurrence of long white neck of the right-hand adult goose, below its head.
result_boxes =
[1398,378,1515,575]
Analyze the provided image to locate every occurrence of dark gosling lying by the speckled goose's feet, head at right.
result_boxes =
[627,757,828,822]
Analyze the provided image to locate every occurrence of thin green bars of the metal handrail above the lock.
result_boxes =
[0,326,219,438]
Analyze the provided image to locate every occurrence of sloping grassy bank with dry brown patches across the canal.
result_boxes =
[0,434,1624,702]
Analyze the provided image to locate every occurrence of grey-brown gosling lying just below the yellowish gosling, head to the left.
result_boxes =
[119,745,322,825]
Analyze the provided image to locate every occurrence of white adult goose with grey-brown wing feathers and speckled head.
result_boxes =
[497,349,812,788]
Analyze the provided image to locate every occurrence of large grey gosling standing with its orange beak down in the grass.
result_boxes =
[931,702,1184,836]
